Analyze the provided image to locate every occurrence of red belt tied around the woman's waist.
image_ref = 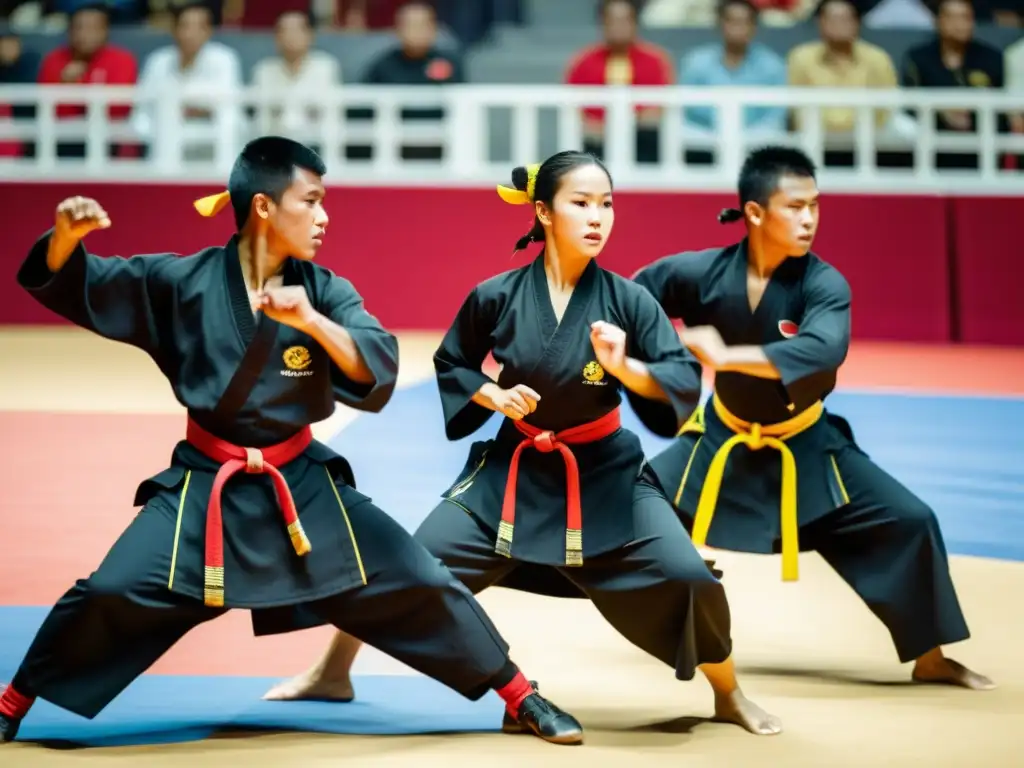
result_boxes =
[495,408,622,565]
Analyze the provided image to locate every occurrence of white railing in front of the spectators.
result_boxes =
[0,85,1024,195]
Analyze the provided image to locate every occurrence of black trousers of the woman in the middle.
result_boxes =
[416,482,732,680]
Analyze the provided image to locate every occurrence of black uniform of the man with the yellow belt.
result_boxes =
[635,241,970,662]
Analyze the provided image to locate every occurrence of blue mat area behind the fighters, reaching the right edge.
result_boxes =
[332,382,1024,560]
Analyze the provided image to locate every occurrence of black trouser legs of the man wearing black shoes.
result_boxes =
[12,502,508,718]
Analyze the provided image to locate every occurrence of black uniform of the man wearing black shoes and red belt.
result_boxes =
[12,234,508,718]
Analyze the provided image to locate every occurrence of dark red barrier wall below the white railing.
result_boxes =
[0,183,999,343]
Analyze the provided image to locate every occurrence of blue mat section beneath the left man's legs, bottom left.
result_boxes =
[0,607,502,749]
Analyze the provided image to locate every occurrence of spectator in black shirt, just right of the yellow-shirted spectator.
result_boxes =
[902,0,1007,168]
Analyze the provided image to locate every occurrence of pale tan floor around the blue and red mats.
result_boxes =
[0,331,1024,768]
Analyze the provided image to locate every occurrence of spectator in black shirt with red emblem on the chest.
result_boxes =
[349,0,465,160]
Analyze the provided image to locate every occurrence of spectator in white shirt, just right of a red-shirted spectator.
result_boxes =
[134,2,243,160]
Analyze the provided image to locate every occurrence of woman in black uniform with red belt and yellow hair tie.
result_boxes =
[267,152,781,734]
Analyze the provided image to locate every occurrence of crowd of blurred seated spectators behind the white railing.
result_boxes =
[0,0,1024,171]
